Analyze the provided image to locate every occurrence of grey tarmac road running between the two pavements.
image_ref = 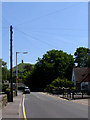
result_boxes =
[23,92,88,118]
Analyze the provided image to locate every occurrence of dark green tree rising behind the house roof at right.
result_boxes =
[74,47,90,67]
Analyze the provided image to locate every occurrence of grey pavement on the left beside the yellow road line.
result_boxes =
[2,92,23,118]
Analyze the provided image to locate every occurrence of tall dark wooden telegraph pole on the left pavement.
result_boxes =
[10,25,13,102]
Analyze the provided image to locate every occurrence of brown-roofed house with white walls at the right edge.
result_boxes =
[72,67,90,90]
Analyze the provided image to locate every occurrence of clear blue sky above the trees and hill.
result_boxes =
[2,2,88,68]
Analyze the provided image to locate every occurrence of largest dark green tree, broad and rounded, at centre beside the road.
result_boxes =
[23,50,74,89]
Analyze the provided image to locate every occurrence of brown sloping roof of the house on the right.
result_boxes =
[73,67,88,83]
